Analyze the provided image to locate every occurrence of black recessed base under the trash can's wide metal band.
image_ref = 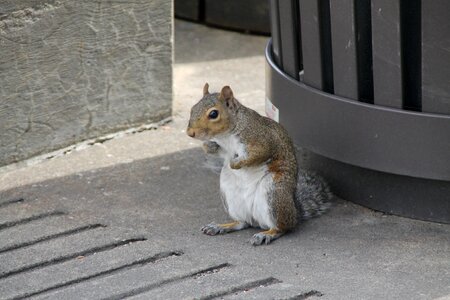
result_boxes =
[298,149,450,223]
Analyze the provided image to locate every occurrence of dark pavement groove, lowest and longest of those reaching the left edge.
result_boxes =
[0,237,147,279]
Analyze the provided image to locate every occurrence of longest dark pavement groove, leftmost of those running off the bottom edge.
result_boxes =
[10,250,184,300]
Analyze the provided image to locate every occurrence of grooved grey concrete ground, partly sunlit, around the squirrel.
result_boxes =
[0,21,450,299]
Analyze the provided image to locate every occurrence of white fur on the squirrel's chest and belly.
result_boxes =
[215,136,276,229]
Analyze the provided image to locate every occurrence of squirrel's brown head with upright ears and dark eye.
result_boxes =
[186,83,239,140]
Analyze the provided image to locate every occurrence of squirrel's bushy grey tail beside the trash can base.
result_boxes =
[295,170,333,220]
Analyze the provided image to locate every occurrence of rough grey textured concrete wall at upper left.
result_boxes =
[0,0,172,166]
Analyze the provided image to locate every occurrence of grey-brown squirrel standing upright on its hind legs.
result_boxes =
[186,83,332,245]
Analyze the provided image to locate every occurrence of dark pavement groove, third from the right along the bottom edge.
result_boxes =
[102,263,231,300]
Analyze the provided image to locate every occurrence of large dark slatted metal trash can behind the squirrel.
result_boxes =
[266,0,450,223]
